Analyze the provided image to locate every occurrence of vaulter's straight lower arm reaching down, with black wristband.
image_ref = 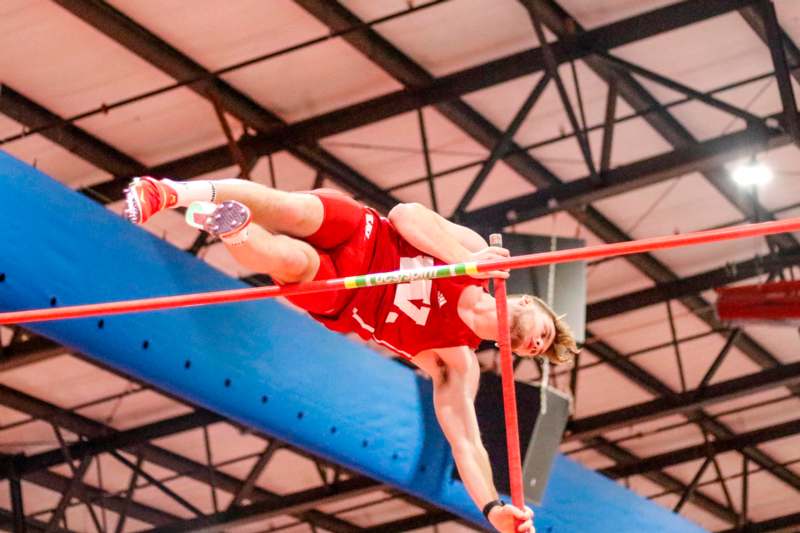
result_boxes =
[414,346,532,533]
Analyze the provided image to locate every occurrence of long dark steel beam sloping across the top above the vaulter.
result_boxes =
[81,0,757,198]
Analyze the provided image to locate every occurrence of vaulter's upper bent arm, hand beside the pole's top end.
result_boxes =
[389,203,508,277]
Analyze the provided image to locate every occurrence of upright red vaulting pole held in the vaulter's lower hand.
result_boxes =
[489,233,525,526]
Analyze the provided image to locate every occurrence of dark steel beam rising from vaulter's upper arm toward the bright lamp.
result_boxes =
[462,117,792,227]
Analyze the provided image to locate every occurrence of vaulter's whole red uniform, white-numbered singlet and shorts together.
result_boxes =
[289,191,484,359]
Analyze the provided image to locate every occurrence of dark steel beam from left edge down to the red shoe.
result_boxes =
[0,85,146,176]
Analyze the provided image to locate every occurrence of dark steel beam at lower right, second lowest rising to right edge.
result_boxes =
[601,419,800,479]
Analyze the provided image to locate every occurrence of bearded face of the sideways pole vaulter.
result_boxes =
[509,295,556,357]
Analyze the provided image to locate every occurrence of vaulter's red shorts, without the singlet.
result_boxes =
[288,189,377,316]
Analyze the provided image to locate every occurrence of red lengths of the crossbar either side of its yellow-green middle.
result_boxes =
[0,218,800,324]
